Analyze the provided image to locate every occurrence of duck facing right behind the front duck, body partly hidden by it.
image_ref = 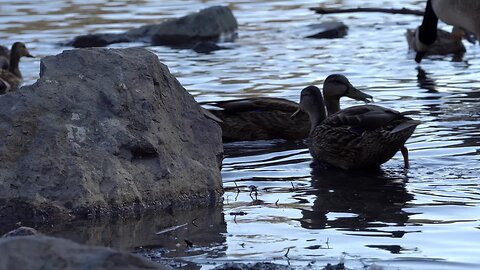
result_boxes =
[201,74,373,142]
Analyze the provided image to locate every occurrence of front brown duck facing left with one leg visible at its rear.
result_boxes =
[291,80,420,170]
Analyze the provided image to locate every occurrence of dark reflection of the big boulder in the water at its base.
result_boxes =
[35,205,227,268]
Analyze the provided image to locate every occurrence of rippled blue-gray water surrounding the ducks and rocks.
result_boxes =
[0,0,480,269]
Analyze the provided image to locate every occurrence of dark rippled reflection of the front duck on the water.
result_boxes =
[300,167,413,237]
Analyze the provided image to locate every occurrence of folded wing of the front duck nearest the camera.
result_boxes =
[324,105,405,130]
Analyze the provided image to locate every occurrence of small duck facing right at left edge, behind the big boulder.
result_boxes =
[0,42,33,94]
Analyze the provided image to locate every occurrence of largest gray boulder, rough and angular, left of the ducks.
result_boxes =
[0,48,223,224]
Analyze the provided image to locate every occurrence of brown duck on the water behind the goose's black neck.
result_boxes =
[405,29,466,55]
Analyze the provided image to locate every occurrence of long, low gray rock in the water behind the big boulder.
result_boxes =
[68,6,238,48]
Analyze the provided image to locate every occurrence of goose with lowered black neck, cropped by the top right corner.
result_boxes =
[415,0,480,63]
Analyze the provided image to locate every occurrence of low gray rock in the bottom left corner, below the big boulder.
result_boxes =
[0,236,170,270]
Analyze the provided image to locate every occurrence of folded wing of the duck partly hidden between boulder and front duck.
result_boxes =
[200,97,298,113]
